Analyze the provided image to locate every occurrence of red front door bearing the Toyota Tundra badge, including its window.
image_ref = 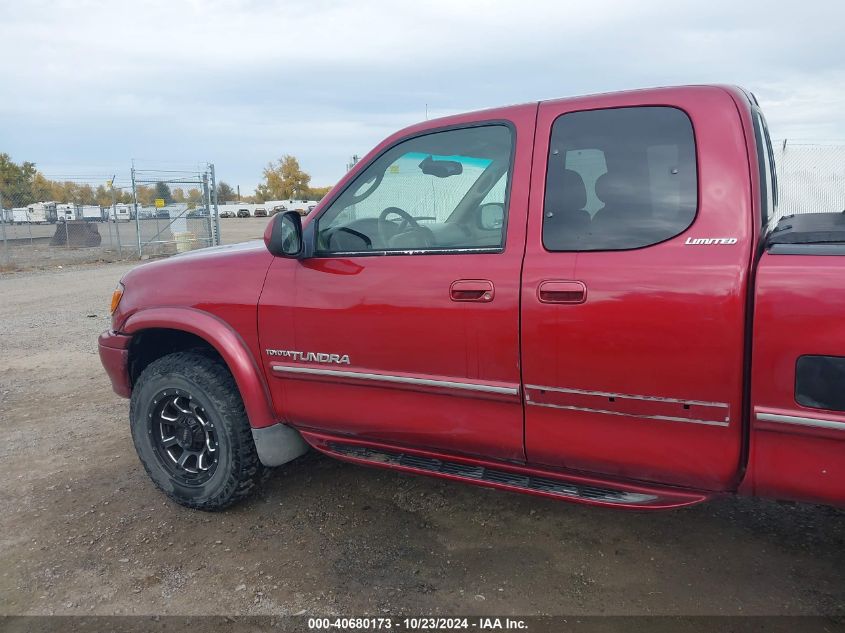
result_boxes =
[259,112,536,460]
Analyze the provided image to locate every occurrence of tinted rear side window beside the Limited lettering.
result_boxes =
[543,107,698,251]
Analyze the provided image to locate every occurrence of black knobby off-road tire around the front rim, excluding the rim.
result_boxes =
[129,350,269,511]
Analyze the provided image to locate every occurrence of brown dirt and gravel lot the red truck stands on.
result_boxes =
[0,253,845,615]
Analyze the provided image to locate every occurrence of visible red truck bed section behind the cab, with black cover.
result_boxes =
[745,213,845,503]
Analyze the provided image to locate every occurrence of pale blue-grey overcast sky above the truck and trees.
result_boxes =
[0,0,845,193]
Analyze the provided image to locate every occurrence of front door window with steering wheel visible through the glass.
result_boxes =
[317,125,512,253]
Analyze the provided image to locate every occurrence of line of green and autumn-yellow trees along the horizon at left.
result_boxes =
[0,153,331,208]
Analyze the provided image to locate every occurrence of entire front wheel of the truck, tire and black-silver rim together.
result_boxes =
[129,351,267,510]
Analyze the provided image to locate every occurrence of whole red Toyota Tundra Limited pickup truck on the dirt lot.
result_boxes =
[99,86,845,510]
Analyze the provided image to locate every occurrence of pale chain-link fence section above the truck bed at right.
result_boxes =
[773,140,845,222]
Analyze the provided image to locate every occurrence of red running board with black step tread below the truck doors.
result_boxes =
[303,431,708,510]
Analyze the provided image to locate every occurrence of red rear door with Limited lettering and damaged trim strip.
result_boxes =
[522,88,752,490]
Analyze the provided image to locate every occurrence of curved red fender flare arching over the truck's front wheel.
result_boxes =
[121,307,277,428]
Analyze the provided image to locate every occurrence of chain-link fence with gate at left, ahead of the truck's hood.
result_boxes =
[0,164,220,270]
